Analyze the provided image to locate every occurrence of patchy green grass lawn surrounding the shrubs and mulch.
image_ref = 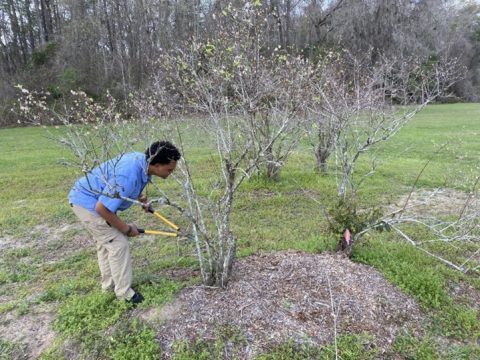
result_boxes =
[0,104,480,359]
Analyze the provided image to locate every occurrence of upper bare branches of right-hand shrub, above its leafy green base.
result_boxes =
[312,52,462,200]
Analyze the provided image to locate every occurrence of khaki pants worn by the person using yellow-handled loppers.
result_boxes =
[72,205,135,300]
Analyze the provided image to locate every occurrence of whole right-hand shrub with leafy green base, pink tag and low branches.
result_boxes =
[300,49,480,272]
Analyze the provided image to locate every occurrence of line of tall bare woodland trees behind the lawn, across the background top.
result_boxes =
[0,0,480,123]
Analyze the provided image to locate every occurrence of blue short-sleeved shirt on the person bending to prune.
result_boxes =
[68,152,151,213]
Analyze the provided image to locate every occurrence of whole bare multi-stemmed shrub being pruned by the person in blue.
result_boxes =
[15,2,312,287]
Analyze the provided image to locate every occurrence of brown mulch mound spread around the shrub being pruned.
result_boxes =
[151,251,424,359]
